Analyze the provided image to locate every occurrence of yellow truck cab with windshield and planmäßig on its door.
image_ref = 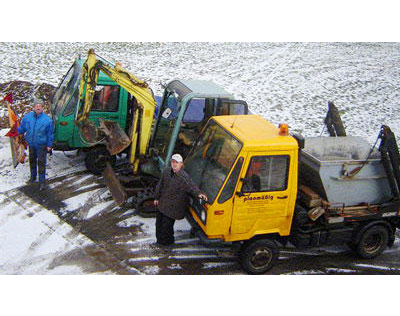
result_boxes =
[185,115,299,242]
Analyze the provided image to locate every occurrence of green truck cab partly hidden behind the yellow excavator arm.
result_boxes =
[51,59,129,152]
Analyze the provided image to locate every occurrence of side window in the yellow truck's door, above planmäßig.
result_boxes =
[242,155,290,193]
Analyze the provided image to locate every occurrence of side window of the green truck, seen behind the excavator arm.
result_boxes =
[91,86,119,112]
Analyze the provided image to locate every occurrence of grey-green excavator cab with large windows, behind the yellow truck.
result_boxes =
[150,80,248,169]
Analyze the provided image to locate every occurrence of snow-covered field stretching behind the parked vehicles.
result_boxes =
[0,42,400,144]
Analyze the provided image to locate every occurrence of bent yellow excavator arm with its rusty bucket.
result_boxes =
[76,49,156,173]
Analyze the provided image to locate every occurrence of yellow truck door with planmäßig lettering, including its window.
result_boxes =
[231,152,291,234]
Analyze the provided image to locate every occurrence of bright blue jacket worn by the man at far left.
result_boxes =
[18,112,54,147]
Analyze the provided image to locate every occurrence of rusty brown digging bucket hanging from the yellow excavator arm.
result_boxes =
[99,119,131,155]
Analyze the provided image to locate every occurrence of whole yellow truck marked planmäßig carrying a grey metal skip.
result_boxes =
[185,115,400,274]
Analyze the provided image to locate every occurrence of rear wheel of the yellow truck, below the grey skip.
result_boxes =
[356,225,389,259]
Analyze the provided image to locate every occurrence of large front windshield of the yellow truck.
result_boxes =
[185,120,243,204]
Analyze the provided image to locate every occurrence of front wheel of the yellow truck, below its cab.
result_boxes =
[239,239,279,274]
